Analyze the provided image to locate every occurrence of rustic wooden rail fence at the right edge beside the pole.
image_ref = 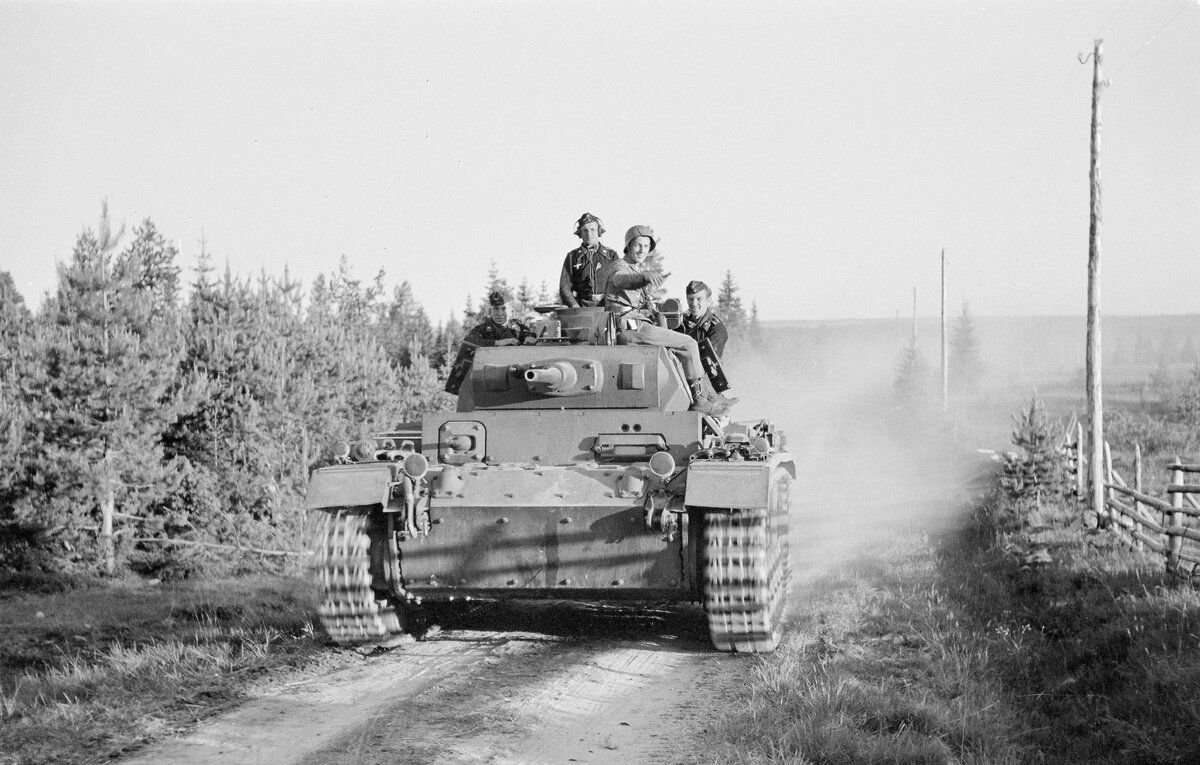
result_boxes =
[1063,422,1200,577]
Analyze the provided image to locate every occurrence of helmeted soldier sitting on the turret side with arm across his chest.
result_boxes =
[605,225,736,417]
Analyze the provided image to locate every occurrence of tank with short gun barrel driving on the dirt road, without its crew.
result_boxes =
[306,308,796,652]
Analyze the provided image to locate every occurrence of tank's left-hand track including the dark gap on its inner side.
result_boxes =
[317,507,406,646]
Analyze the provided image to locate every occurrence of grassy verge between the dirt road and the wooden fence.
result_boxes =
[704,482,1200,764]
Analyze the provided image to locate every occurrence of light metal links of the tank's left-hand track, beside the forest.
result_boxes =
[317,510,403,646]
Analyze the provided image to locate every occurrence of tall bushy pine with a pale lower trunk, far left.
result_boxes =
[24,213,188,573]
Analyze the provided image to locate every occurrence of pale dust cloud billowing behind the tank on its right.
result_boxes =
[727,325,989,580]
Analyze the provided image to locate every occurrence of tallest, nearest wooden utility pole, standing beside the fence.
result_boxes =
[1087,40,1106,524]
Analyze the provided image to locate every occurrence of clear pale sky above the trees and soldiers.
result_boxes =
[0,0,1200,320]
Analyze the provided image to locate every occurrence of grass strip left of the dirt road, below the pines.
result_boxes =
[0,578,329,765]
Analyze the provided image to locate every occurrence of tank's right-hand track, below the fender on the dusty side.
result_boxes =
[704,468,792,653]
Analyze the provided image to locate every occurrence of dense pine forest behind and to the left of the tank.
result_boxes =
[0,207,757,576]
